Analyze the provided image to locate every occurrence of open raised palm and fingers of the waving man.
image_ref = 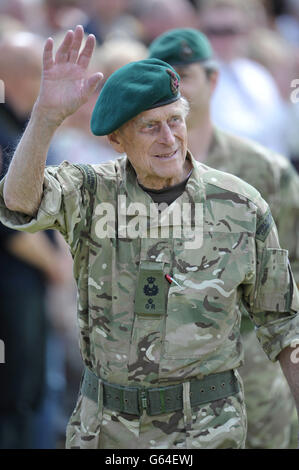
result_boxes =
[37,26,103,122]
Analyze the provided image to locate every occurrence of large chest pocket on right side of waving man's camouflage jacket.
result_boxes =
[163,232,254,360]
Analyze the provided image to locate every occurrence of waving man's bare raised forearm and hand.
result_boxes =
[3,26,103,216]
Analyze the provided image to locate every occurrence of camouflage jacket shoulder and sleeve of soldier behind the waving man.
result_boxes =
[205,127,299,284]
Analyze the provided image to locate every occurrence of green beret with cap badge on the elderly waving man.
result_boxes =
[90,59,181,135]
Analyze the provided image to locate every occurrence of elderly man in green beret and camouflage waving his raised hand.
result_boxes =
[0,26,299,449]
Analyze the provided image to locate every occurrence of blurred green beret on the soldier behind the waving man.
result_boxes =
[149,28,213,66]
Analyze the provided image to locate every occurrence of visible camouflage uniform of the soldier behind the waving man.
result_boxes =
[206,128,299,449]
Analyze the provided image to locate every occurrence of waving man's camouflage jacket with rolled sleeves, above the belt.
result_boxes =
[0,155,299,386]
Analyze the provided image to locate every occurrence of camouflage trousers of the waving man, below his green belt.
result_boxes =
[66,372,246,449]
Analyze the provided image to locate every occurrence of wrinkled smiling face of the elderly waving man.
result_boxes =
[110,100,191,189]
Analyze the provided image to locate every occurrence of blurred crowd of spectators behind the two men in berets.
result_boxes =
[0,0,299,448]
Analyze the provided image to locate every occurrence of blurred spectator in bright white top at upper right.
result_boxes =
[197,0,288,157]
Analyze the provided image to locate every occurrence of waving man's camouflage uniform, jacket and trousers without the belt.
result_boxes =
[0,156,299,449]
